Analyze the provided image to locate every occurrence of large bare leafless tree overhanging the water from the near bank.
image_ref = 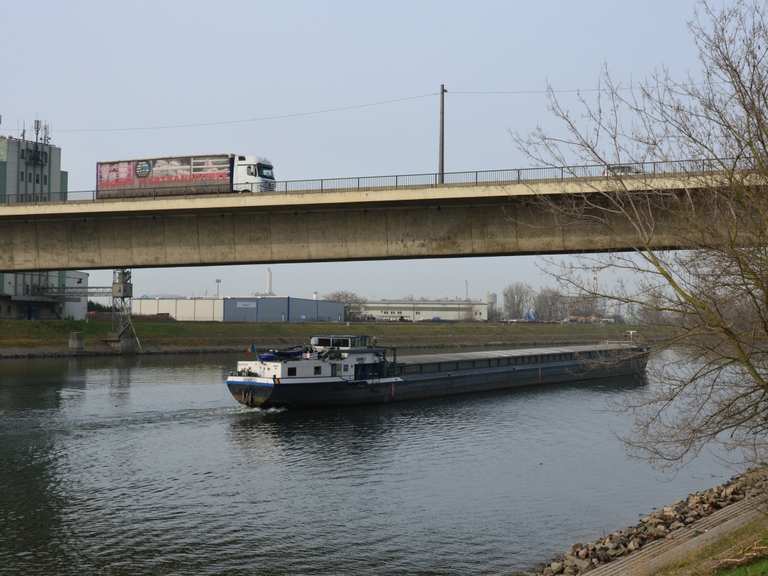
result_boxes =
[516,0,768,463]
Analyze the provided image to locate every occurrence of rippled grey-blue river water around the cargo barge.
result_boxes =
[0,355,733,575]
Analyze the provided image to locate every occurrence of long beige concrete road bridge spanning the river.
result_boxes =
[0,162,720,272]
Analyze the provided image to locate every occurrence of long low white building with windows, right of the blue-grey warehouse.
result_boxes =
[356,299,488,322]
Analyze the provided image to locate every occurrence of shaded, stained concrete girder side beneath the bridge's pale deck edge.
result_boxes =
[0,197,671,272]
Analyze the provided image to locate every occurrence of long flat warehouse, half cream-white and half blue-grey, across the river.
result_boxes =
[132,296,344,322]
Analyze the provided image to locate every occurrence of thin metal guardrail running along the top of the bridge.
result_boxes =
[0,158,752,204]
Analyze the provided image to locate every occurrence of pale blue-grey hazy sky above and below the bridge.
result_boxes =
[0,0,697,299]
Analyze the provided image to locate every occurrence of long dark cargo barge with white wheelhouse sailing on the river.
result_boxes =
[226,336,648,408]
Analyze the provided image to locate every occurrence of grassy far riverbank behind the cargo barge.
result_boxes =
[0,320,630,351]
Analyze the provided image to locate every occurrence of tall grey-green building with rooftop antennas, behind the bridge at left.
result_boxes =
[0,134,88,320]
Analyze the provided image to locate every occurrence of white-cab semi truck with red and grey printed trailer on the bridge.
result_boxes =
[96,154,275,200]
